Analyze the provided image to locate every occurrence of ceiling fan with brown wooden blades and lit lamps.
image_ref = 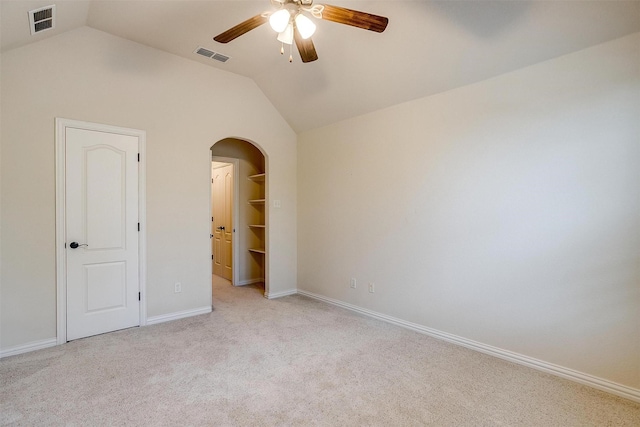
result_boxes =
[213,0,389,62]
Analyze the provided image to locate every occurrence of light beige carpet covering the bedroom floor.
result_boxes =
[0,281,640,426]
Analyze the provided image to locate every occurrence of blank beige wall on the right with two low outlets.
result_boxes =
[298,34,640,388]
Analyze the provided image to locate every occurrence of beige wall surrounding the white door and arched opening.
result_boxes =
[0,27,296,350]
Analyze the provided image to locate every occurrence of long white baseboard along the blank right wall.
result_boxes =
[298,289,640,402]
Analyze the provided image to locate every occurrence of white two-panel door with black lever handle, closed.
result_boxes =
[65,127,140,340]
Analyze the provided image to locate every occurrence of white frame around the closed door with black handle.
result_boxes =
[55,117,147,344]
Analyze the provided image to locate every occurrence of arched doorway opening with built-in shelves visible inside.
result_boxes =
[211,138,269,294]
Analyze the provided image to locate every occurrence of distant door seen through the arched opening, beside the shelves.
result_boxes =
[211,164,233,280]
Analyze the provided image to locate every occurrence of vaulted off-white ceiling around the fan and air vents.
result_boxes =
[0,0,640,132]
